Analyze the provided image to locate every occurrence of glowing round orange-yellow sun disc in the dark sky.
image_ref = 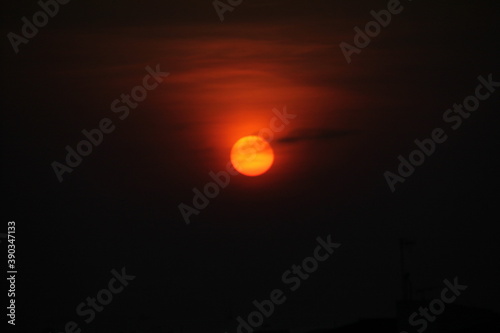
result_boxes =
[231,135,274,177]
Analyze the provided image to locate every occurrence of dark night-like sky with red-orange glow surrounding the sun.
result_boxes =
[0,0,500,332]
